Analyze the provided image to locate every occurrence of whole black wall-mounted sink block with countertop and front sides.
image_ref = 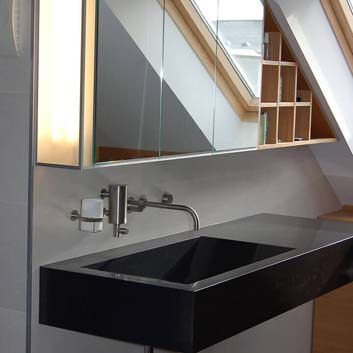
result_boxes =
[39,215,353,353]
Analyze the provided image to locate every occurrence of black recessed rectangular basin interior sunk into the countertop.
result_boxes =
[87,237,293,284]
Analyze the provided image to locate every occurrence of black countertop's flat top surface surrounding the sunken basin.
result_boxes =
[45,214,353,291]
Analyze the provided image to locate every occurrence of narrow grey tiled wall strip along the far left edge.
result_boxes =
[0,0,31,353]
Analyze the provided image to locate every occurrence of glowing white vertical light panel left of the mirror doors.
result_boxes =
[37,0,82,166]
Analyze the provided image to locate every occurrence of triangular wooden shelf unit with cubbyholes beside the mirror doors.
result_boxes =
[258,6,337,149]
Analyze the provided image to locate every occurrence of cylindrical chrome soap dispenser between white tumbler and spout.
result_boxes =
[101,184,129,237]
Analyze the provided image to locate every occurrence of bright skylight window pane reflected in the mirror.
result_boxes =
[193,0,264,97]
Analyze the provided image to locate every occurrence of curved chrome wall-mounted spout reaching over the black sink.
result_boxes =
[127,193,200,230]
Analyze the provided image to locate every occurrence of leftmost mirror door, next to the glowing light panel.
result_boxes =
[95,0,163,162]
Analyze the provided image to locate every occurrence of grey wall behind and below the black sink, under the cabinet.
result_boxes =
[32,147,339,353]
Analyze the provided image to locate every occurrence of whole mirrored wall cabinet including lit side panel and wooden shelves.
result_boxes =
[36,0,335,168]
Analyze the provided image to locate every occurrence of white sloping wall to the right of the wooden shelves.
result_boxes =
[271,0,353,204]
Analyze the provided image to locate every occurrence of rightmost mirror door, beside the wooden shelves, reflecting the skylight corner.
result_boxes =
[212,0,264,151]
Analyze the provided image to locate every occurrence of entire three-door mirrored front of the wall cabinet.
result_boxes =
[95,0,264,163]
